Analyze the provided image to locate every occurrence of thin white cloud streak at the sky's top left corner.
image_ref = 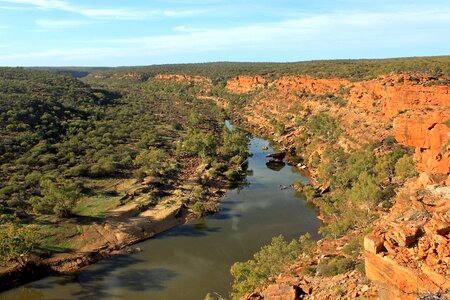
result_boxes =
[0,0,203,20]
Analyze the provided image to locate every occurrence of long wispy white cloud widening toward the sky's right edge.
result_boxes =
[109,10,450,53]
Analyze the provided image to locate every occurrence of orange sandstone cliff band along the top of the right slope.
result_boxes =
[227,75,450,174]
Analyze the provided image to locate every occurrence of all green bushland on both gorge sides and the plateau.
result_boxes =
[0,56,444,297]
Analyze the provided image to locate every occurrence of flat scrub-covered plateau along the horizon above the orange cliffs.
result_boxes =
[47,56,450,85]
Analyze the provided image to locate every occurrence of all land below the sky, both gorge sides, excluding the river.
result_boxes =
[0,56,450,299]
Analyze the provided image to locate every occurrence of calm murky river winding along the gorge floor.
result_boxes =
[0,138,320,300]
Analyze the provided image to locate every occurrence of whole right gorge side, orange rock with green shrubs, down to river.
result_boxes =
[146,60,450,299]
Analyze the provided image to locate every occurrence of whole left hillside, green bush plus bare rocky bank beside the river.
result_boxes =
[0,68,247,289]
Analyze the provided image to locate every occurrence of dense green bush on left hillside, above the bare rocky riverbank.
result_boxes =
[0,68,247,261]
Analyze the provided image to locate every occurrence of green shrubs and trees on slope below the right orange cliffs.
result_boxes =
[296,112,416,239]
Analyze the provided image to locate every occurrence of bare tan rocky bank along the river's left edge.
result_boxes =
[0,161,237,291]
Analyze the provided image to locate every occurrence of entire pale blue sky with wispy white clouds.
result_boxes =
[0,0,450,66]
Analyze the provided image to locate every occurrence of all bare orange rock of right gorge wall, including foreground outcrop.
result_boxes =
[156,74,450,299]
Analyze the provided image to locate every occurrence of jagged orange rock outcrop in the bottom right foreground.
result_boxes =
[364,176,450,299]
